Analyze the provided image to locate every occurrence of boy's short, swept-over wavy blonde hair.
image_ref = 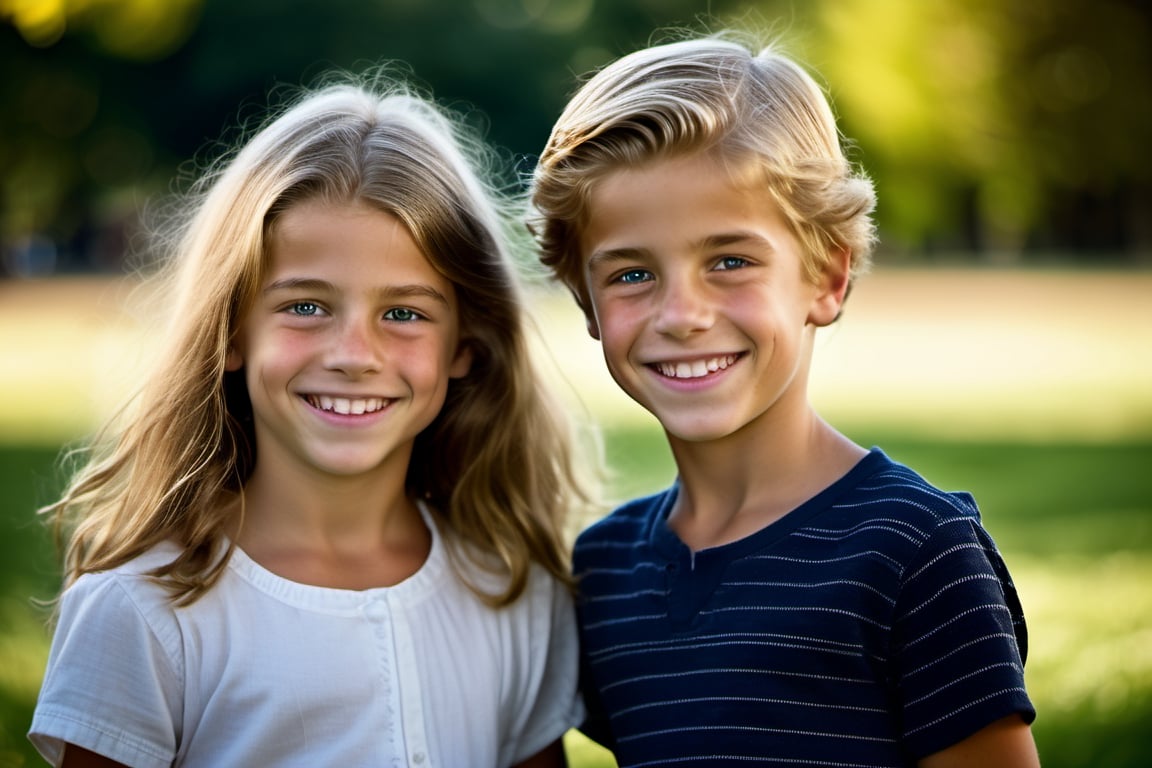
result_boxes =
[529,33,876,312]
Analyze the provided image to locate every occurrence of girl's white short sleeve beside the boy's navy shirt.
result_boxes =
[511,570,584,765]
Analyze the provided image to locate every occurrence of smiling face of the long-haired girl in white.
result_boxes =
[228,201,471,477]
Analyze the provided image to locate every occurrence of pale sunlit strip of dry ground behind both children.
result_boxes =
[0,269,1152,443]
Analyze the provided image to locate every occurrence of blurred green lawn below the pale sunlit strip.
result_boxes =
[0,435,1152,768]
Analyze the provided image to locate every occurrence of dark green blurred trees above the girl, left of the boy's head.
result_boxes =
[0,0,719,269]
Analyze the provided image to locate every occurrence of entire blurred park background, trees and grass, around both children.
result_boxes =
[0,0,1152,768]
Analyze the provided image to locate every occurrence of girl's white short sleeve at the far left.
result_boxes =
[29,573,182,768]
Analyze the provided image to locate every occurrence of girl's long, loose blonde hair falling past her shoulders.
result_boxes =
[41,71,590,606]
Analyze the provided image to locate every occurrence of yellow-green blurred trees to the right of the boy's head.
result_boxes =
[792,0,1152,258]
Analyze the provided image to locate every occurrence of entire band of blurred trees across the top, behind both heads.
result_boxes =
[0,0,1152,275]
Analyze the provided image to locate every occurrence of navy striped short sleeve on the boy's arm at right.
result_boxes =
[894,515,1036,758]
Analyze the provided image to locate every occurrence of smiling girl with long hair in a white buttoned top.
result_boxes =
[30,71,588,767]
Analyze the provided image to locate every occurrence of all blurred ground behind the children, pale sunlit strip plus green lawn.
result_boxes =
[0,272,1152,768]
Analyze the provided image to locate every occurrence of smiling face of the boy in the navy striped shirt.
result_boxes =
[581,154,848,442]
